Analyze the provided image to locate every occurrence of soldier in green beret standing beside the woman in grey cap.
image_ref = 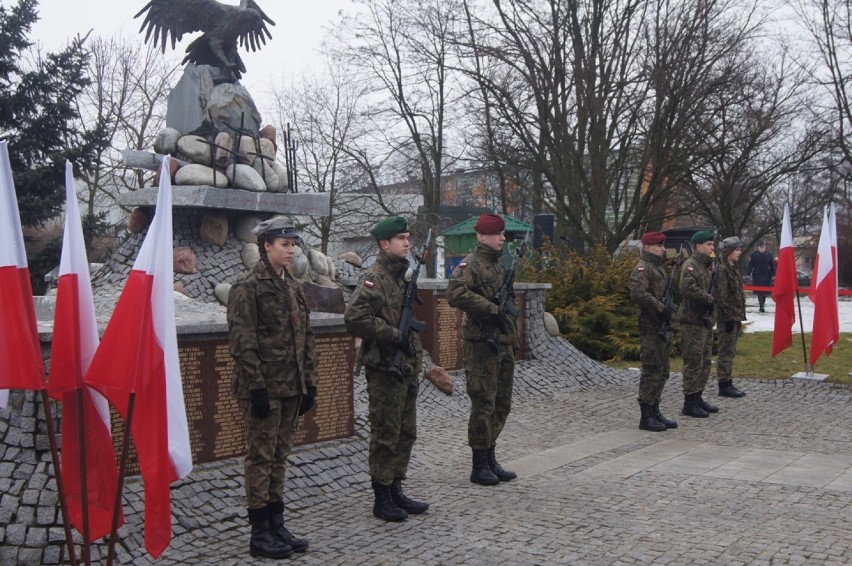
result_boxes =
[344,216,429,521]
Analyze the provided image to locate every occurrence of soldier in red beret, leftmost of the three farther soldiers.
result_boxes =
[630,232,677,431]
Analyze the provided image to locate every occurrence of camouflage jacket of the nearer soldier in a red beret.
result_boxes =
[447,242,518,348]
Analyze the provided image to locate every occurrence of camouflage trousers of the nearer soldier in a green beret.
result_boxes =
[364,367,420,485]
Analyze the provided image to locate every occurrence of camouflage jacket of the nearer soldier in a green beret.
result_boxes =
[343,250,422,375]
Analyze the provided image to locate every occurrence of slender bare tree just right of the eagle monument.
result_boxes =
[328,0,463,235]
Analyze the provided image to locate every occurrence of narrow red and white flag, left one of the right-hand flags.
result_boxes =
[772,204,798,356]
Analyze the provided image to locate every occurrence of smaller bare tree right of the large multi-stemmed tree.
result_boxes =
[680,49,825,251]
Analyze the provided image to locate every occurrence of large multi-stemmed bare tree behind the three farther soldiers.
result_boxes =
[465,0,772,253]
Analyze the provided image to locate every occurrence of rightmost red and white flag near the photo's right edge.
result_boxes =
[810,204,840,365]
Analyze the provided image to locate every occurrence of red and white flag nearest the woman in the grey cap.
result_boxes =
[84,157,192,558]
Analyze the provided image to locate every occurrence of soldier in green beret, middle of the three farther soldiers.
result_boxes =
[676,230,719,418]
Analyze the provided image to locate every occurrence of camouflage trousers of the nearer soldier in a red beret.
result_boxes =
[464,340,515,450]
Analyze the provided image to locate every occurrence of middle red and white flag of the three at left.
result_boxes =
[47,162,124,542]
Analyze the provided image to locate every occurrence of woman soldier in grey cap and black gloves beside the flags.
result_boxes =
[228,216,317,558]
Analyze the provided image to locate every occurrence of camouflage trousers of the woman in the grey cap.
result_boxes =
[240,396,301,509]
